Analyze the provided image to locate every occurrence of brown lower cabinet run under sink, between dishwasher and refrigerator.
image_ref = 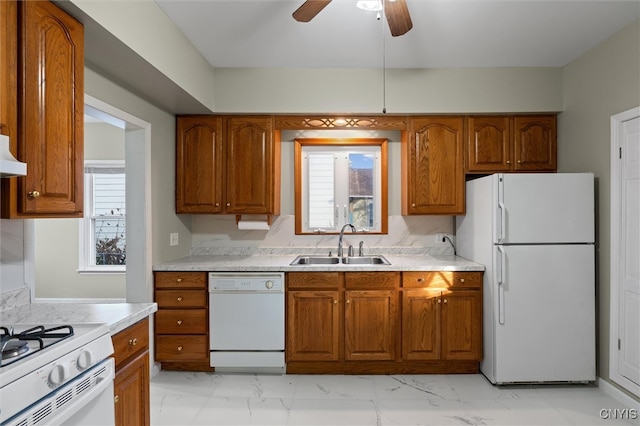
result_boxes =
[286,271,482,374]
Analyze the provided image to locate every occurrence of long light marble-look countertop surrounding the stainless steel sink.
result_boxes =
[153,255,485,272]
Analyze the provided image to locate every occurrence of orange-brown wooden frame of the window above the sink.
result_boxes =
[293,138,389,235]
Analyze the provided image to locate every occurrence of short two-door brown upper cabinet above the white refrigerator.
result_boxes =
[466,115,557,173]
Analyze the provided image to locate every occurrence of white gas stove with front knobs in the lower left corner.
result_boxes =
[0,324,114,426]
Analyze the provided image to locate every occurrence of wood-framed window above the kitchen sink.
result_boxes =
[294,138,388,234]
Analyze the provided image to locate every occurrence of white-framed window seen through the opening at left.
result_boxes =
[79,161,127,272]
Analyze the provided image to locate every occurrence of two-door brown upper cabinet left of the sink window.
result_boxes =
[176,116,280,215]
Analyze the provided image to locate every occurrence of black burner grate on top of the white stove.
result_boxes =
[0,325,73,367]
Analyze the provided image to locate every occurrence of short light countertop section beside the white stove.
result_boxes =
[0,303,158,336]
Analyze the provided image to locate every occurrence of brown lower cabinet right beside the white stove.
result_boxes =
[113,319,151,426]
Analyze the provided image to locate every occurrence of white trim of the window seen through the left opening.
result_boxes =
[78,160,127,274]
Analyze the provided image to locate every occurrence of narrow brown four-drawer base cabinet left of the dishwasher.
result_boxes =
[154,272,211,371]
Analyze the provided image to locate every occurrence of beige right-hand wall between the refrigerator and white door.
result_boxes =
[558,21,640,402]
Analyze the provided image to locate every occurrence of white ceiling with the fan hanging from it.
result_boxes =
[155,0,640,68]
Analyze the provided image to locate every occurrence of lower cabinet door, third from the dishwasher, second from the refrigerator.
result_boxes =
[402,288,441,360]
